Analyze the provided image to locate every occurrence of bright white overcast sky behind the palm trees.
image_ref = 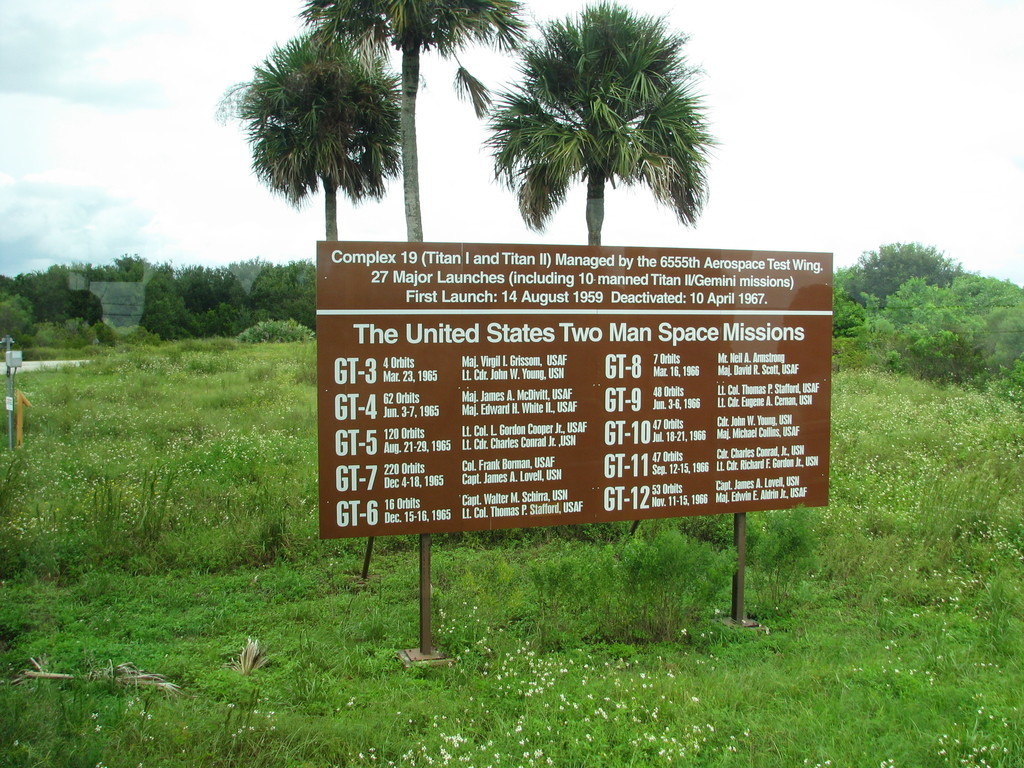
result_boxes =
[0,0,1024,283]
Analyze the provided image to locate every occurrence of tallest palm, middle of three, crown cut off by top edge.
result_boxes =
[301,0,525,243]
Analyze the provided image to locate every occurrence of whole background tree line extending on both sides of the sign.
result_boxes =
[0,243,1024,397]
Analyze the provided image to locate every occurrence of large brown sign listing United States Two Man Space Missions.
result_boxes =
[316,243,831,538]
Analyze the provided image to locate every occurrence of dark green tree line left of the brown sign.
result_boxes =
[0,255,316,349]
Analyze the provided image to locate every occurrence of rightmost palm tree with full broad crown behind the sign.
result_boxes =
[487,3,714,245]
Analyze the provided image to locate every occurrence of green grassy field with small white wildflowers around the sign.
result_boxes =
[0,342,1024,768]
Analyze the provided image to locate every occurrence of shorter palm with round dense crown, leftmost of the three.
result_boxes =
[221,34,399,240]
